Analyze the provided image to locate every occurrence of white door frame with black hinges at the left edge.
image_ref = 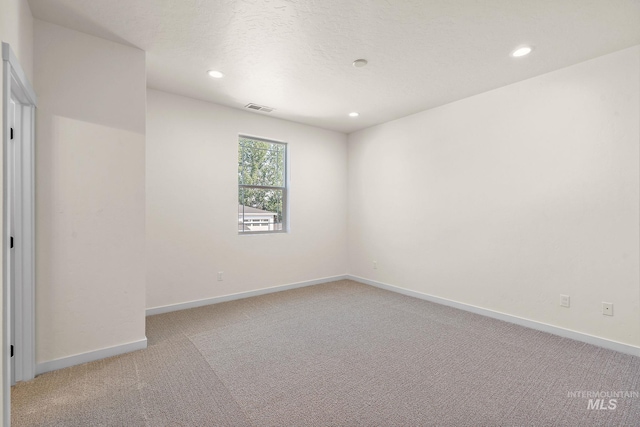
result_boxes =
[2,43,37,425]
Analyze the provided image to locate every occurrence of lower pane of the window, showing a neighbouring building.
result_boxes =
[238,187,284,233]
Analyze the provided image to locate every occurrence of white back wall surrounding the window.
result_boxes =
[146,90,347,308]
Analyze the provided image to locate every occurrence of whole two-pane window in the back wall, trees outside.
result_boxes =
[238,135,287,234]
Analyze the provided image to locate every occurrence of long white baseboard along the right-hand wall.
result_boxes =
[347,275,640,356]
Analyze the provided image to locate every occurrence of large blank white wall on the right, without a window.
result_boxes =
[348,47,640,346]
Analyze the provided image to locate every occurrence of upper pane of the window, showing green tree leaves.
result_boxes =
[238,136,285,187]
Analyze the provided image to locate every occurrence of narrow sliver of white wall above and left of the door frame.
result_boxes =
[0,0,33,422]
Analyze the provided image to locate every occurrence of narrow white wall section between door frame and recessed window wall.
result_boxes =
[34,20,146,363]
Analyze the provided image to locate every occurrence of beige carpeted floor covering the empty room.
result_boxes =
[12,281,640,427]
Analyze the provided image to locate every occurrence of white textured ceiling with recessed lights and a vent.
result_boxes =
[29,0,640,133]
